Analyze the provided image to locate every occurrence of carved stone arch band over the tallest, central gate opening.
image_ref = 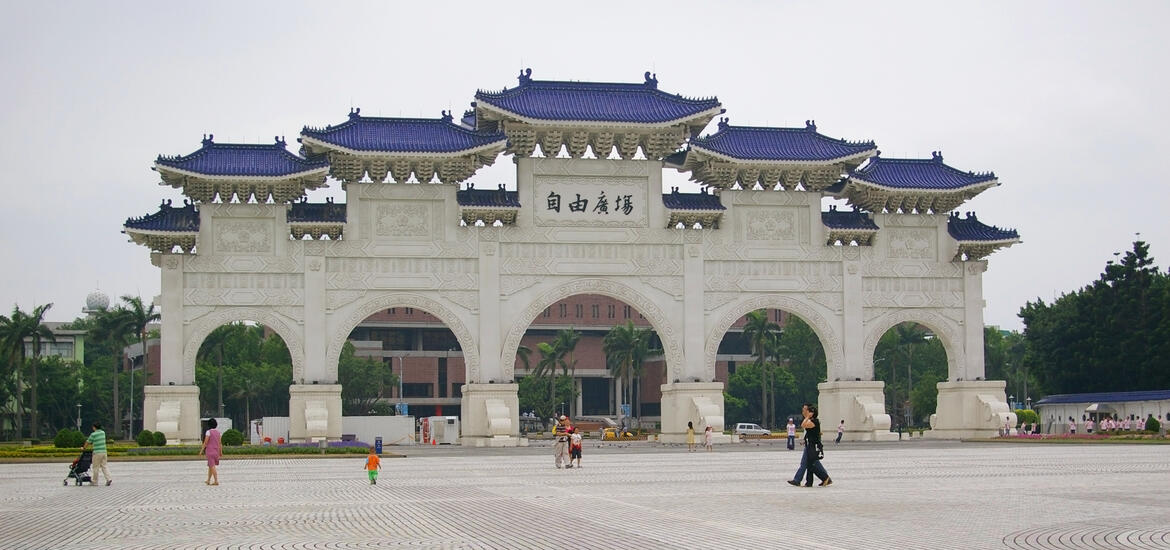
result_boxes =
[500,279,682,381]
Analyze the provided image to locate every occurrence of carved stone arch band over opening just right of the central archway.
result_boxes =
[703,295,845,380]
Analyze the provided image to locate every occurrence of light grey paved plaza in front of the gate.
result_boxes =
[0,441,1170,550]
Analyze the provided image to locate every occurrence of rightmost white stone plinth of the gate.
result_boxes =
[928,380,1016,439]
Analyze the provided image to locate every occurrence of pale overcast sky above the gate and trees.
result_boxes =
[0,1,1170,329]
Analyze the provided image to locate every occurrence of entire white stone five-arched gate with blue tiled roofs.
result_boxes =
[124,69,1019,446]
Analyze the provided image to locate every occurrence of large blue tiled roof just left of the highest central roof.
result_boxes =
[301,109,508,153]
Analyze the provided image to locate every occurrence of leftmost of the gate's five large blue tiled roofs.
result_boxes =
[156,136,329,177]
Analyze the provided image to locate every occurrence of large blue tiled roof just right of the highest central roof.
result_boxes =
[690,118,875,161]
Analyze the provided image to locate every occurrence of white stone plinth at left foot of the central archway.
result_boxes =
[460,384,527,447]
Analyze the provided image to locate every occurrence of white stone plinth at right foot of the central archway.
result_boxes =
[659,381,731,445]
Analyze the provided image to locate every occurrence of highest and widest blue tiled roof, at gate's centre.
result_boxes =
[475,69,720,124]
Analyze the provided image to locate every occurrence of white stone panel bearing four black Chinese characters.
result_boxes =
[532,176,649,227]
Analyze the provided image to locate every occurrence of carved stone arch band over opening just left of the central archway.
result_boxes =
[325,293,480,381]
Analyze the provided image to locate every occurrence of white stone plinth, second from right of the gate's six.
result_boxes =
[819,380,897,441]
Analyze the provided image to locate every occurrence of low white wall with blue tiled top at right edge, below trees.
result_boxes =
[1035,390,1170,433]
